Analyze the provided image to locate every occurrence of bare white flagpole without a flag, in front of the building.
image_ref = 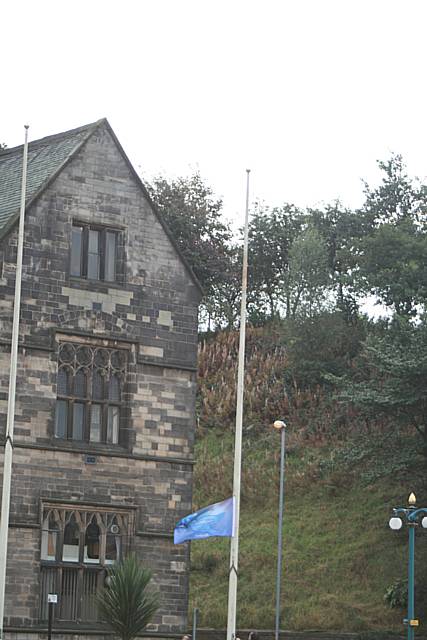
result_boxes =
[0,125,28,639]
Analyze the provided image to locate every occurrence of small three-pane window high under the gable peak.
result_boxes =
[70,223,119,282]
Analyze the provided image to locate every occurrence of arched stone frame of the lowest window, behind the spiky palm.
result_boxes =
[39,502,135,624]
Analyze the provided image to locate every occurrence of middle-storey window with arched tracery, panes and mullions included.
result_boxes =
[55,342,127,444]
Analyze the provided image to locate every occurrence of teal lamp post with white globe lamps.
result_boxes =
[389,493,427,640]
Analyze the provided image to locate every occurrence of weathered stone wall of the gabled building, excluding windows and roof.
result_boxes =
[0,125,200,640]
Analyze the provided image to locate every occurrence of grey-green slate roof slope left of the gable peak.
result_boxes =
[0,120,103,236]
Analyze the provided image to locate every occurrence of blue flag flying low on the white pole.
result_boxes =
[173,498,234,544]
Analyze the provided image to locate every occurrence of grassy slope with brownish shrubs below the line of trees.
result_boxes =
[191,328,427,632]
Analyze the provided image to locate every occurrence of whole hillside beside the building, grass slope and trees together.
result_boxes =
[149,154,427,632]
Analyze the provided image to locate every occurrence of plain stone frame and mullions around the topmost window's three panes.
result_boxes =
[69,219,125,286]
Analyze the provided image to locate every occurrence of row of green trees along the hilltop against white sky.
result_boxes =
[149,155,427,331]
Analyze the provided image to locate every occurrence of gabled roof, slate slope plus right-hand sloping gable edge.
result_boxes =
[0,118,203,295]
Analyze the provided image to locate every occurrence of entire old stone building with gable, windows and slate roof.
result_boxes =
[0,120,201,640]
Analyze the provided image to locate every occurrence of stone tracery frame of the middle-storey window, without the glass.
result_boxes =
[53,335,131,447]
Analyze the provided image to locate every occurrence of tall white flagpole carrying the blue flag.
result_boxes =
[227,169,250,640]
